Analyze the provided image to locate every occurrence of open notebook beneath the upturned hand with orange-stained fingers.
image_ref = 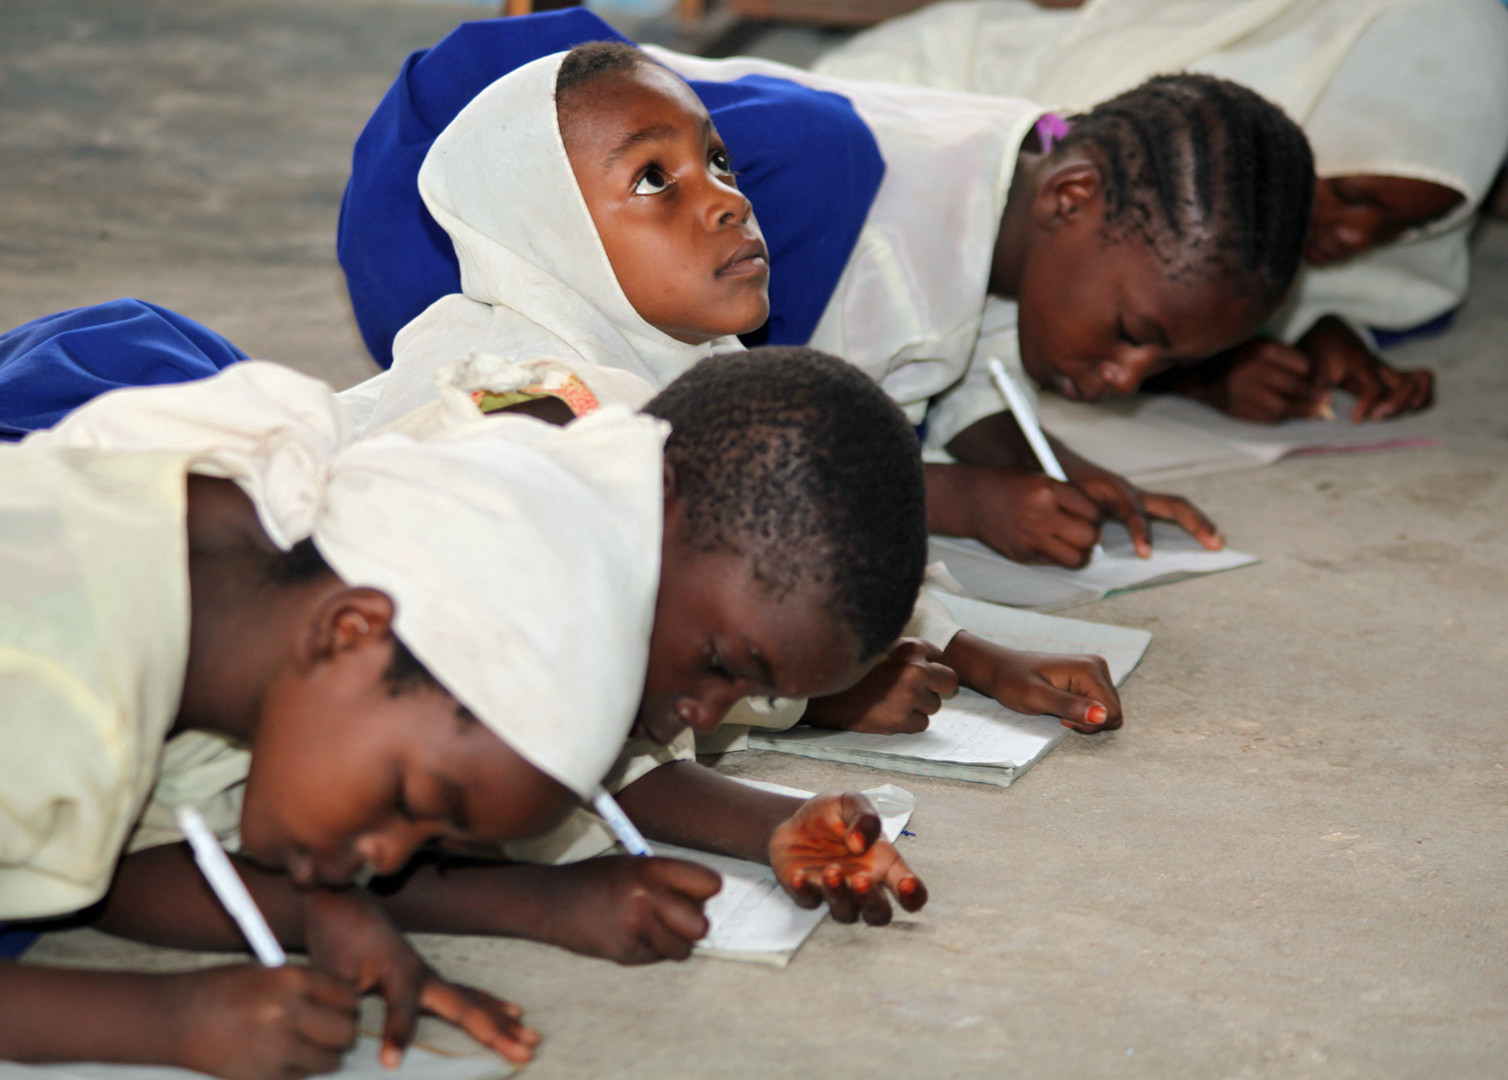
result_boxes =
[654,780,917,967]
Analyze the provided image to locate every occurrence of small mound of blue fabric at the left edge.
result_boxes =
[0,299,246,439]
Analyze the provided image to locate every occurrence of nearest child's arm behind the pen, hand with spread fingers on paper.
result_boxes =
[93,845,538,1063]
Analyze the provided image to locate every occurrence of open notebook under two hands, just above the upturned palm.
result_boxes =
[748,593,1152,787]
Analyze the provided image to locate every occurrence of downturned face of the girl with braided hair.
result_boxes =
[1016,205,1270,401]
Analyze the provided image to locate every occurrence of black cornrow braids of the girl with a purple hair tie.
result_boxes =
[1059,74,1315,305]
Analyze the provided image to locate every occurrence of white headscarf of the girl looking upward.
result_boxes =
[371,53,740,427]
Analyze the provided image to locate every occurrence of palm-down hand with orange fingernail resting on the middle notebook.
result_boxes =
[944,631,1120,735]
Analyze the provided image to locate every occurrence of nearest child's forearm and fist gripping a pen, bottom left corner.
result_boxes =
[0,961,357,1080]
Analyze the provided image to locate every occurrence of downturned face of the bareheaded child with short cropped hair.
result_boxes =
[633,497,872,744]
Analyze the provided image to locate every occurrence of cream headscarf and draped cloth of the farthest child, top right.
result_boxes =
[816,0,1508,338]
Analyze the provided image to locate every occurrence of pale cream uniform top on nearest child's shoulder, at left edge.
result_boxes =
[0,446,189,920]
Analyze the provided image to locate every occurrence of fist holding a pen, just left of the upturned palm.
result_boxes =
[531,855,722,964]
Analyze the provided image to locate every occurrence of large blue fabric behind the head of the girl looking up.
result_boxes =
[336,8,885,367]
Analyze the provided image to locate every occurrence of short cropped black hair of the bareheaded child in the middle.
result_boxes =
[644,347,927,659]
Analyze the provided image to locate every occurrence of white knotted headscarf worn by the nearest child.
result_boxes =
[30,361,667,796]
